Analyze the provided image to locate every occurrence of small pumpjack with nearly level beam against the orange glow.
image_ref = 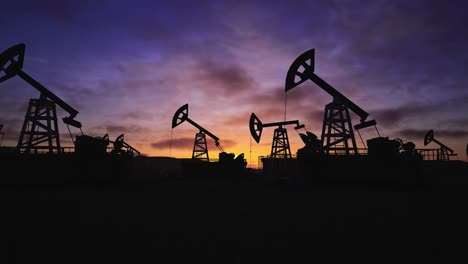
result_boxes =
[249,113,308,159]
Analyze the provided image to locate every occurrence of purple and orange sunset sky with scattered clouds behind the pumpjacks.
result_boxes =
[0,0,468,165]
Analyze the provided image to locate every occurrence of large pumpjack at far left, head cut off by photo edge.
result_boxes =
[0,44,81,153]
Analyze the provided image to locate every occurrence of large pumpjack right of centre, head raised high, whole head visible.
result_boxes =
[285,49,378,155]
